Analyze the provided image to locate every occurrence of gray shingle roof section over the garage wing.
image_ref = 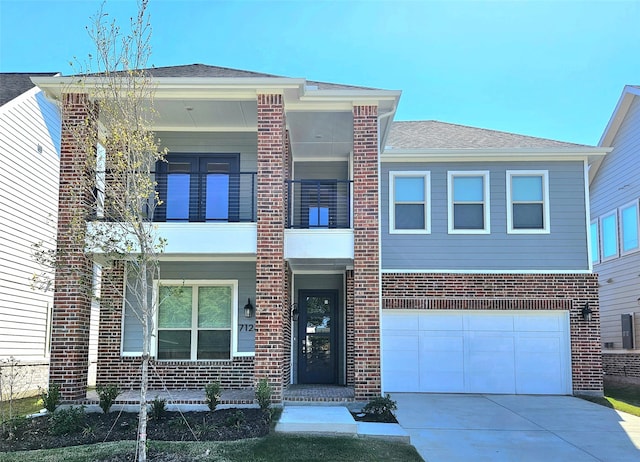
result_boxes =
[386,120,585,150]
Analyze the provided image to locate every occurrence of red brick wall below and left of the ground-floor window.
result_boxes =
[97,262,253,390]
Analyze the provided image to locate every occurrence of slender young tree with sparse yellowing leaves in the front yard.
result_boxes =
[68,0,165,461]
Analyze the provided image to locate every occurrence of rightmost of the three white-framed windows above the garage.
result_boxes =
[507,170,549,234]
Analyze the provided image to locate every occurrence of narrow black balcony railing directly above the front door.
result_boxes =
[287,179,351,229]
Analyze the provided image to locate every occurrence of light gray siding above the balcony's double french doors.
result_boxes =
[156,132,258,172]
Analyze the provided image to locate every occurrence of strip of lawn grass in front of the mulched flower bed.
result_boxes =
[0,433,422,462]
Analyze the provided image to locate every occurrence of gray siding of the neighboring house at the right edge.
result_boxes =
[590,97,640,349]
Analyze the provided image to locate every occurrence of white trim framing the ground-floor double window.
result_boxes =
[150,279,240,362]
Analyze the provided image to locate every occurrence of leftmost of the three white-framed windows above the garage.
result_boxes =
[389,172,431,234]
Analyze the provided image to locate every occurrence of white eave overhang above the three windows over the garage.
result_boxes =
[382,147,611,162]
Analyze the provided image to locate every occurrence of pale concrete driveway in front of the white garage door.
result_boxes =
[391,393,640,462]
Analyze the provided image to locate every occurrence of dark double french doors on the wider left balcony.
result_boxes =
[156,154,240,222]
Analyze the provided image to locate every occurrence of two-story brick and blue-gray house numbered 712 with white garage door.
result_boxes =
[36,64,606,402]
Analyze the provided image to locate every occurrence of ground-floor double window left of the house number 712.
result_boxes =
[156,281,237,360]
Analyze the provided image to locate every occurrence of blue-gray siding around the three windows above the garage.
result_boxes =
[380,161,589,271]
